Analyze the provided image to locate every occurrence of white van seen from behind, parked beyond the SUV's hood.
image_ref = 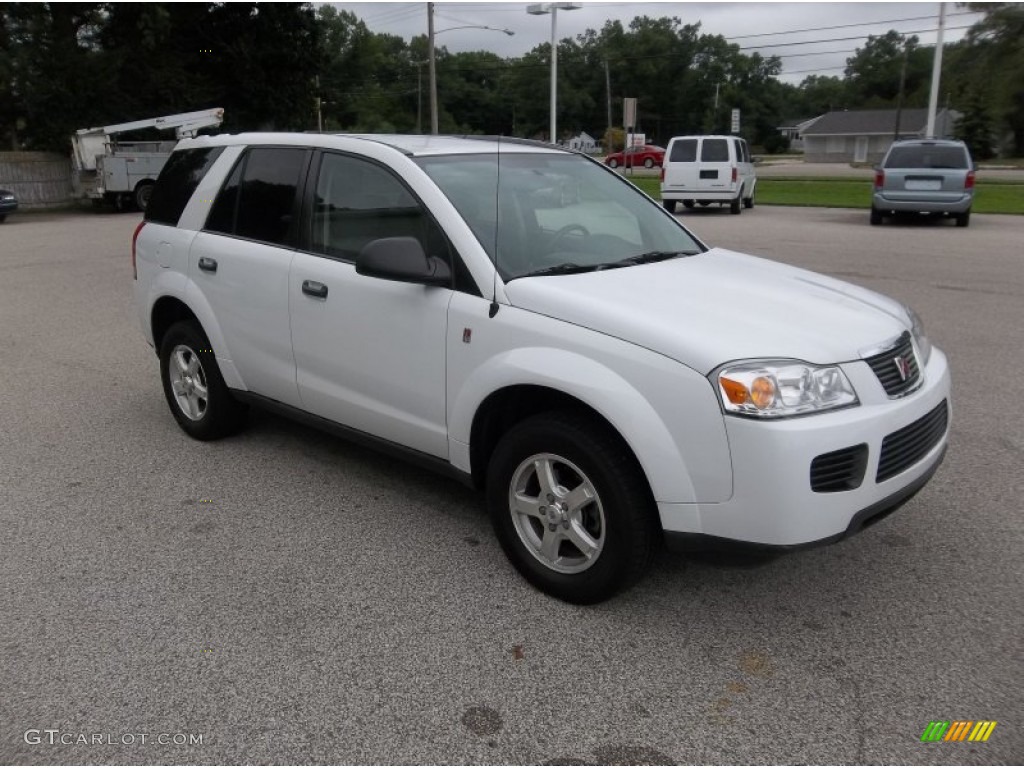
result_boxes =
[662,136,758,213]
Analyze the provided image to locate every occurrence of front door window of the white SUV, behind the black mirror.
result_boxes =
[310,153,452,264]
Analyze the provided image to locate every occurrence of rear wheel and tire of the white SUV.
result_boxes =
[160,321,247,440]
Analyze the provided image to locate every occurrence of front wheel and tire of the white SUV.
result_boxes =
[486,412,659,605]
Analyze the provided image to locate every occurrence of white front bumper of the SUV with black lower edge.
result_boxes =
[658,349,952,548]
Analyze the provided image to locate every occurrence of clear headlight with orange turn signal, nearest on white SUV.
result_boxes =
[714,360,858,419]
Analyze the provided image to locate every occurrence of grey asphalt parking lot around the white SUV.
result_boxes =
[0,207,1024,764]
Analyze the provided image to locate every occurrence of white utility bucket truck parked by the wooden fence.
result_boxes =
[71,109,224,211]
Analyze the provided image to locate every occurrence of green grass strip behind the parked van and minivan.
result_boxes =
[631,177,1024,216]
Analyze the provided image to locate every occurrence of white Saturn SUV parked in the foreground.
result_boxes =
[132,134,950,603]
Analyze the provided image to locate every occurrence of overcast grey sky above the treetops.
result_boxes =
[332,0,981,83]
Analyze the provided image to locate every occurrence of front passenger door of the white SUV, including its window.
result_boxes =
[288,153,452,458]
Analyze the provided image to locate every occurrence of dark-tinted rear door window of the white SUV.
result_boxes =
[206,146,307,246]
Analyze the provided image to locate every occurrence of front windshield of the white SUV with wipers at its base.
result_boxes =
[416,153,703,281]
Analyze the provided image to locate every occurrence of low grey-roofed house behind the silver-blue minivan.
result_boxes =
[802,109,961,163]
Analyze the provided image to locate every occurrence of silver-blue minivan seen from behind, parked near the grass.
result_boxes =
[870,139,974,226]
